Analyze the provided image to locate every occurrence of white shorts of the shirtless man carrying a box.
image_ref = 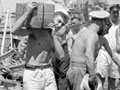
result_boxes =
[23,68,57,90]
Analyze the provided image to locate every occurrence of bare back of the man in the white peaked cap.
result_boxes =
[71,28,100,63]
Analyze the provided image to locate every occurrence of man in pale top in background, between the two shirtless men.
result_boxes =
[67,14,85,56]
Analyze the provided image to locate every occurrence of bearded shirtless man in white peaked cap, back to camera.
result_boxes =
[68,10,120,90]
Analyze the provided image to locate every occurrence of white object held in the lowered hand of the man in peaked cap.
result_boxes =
[80,74,103,90]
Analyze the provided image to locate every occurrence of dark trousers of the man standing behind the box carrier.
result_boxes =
[52,54,70,90]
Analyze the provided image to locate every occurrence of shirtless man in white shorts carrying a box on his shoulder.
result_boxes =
[12,3,64,90]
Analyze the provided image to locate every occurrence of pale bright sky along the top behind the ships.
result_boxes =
[0,0,120,12]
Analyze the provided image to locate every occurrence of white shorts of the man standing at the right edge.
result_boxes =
[95,49,120,78]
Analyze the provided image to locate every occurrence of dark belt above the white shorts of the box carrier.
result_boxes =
[25,64,51,70]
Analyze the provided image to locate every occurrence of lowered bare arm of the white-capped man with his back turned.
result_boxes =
[85,35,98,76]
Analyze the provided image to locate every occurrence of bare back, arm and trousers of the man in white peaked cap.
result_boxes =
[68,24,99,90]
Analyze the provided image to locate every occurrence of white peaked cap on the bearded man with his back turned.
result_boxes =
[89,10,110,19]
